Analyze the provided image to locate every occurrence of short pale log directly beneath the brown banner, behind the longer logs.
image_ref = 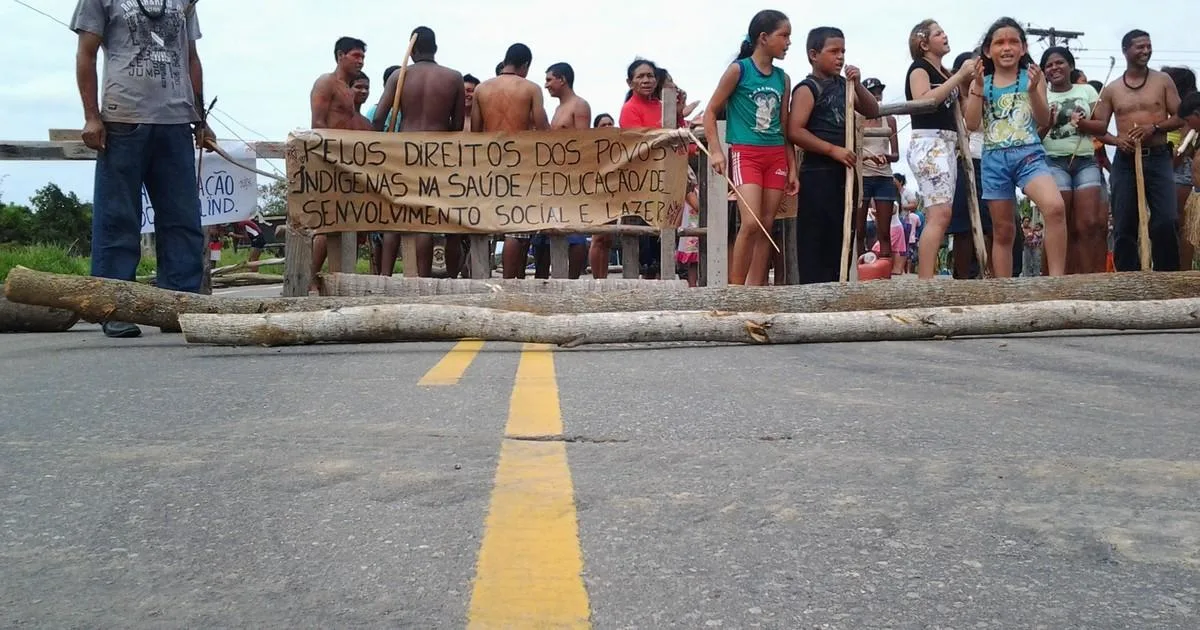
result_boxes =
[318,274,688,296]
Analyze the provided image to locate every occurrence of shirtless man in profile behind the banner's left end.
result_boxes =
[308,37,367,292]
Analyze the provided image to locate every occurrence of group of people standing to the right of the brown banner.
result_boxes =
[704,11,1200,284]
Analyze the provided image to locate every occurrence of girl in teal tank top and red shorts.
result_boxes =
[704,10,799,284]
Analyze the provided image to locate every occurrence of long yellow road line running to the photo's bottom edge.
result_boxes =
[468,343,592,629]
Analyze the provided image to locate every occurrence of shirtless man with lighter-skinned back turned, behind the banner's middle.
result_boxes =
[470,43,550,278]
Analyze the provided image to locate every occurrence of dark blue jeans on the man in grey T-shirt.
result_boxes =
[91,122,204,293]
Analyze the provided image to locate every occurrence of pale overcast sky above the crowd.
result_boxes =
[0,0,1200,203]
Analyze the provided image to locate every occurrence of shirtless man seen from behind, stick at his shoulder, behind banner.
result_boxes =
[371,26,467,277]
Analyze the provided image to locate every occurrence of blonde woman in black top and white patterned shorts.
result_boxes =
[904,19,974,280]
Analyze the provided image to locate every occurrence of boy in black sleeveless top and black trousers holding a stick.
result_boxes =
[787,26,880,284]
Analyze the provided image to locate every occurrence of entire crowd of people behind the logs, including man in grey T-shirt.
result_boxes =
[70,0,1200,337]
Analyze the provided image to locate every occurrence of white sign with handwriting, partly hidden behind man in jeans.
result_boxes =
[142,142,258,234]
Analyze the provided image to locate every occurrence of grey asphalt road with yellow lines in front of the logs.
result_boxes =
[0,283,1200,629]
